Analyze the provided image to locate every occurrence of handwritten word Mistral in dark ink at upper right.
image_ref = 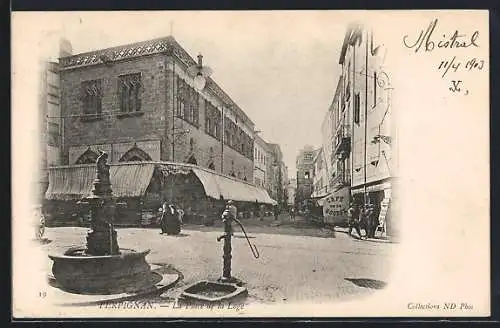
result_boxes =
[403,18,479,52]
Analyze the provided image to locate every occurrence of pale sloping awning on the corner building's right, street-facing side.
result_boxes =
[192,167,277,205]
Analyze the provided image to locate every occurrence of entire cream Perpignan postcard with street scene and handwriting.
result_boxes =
[12,10,490,318]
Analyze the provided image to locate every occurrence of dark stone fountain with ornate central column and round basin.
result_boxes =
[49,152,178,302]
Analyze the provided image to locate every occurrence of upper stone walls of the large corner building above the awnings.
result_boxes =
[60,36,254,182]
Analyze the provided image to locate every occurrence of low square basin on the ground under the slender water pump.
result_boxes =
[180,280,248,302]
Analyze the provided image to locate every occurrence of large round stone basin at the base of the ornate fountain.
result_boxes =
[49,246,154,295]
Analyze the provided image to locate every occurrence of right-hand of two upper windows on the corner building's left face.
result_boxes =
[118,73,142,113]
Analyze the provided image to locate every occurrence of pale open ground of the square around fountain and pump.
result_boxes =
[39,218,396,303]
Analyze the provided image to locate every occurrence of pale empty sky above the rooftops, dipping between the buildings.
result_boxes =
[33,11,352,177]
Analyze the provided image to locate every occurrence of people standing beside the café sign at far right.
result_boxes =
[347,203,379,239]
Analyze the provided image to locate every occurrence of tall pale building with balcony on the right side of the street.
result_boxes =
[335,24,398,235]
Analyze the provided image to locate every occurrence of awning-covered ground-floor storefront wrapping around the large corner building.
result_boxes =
[44,162,276,226]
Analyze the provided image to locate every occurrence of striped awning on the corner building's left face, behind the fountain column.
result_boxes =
[45,163,155,200]
